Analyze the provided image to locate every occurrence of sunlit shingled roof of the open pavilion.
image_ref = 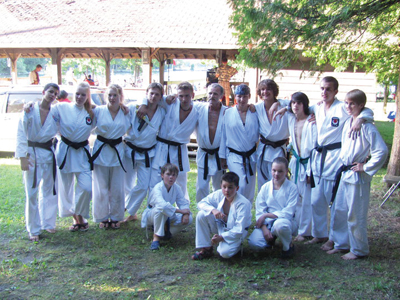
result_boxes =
[0,0,238,58]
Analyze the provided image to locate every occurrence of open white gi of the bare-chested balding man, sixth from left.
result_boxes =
[196,105,227,202]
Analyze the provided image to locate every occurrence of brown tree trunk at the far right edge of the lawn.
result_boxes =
[387,67,400,176]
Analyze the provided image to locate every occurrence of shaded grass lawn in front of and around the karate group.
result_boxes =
[0,122,400,299]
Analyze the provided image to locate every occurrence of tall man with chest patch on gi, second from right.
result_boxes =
[306,76,373,251]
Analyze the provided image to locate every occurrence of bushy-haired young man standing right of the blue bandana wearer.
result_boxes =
[255,79,289,190]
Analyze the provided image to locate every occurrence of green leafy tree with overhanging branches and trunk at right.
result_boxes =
[228,0,400,176]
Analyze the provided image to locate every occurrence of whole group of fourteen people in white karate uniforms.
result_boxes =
[16,77,388,260]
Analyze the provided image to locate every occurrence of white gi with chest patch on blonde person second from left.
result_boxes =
[53,103,94,219]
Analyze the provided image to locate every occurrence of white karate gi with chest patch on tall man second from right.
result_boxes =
[307,98,373,240]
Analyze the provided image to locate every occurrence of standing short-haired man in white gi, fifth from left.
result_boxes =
[148,82,205,201]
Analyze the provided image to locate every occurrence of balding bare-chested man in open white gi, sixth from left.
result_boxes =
[196,83,227,202]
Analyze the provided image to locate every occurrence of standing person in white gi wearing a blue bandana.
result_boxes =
[219,84,258,203]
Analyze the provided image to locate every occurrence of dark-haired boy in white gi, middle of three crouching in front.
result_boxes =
[192,172,251,260]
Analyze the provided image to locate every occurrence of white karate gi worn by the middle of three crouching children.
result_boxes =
[196,190,251,258]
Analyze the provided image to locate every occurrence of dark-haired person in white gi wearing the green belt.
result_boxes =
[287,92,317,242]
